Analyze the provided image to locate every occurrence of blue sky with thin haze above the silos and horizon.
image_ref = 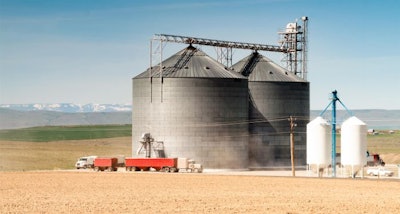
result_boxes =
[0,0,400,109]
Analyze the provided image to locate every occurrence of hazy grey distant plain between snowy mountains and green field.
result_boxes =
[0,108,400,130]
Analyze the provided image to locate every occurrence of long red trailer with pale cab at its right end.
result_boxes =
[125,158,203,173]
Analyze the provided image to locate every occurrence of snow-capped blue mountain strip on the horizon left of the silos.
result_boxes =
[0,103,132,113]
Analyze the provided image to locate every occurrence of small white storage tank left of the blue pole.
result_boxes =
[307,117,332,168]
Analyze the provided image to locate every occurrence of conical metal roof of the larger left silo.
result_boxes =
[134,45,245,79]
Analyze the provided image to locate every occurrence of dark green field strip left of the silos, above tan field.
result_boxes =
[0,124,132,142]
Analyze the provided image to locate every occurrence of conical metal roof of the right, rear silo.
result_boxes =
[232,52,306,82]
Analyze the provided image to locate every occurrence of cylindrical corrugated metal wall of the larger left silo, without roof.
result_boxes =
[132,78,249,168]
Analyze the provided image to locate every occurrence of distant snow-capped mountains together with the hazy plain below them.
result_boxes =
[0,103,400,130]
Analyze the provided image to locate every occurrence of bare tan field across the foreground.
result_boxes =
[0,170,400,213]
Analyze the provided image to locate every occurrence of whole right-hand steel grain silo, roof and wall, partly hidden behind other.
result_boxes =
[232,52,310,168]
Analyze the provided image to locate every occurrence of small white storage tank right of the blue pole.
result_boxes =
[341,116,367,167]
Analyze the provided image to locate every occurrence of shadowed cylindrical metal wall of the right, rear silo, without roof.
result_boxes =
[249,82,310,168]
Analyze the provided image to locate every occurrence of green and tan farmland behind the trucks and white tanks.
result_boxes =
[0,125,400,171]
